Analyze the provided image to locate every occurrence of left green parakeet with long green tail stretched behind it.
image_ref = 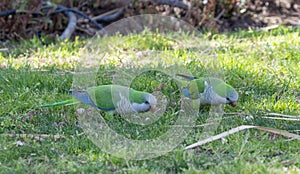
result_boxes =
[40,85,157,114]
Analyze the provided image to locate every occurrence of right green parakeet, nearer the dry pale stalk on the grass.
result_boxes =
[176,74,239,107]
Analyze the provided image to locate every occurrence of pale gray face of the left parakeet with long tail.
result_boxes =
[132,94,157,112]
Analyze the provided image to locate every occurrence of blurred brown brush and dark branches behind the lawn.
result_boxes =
[0,0,300,42]
